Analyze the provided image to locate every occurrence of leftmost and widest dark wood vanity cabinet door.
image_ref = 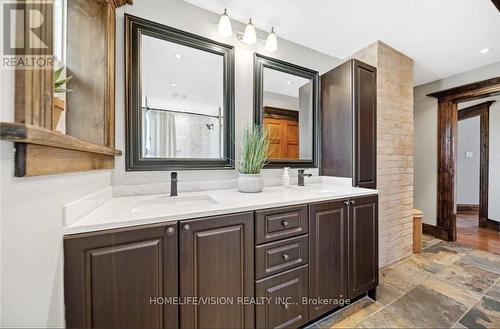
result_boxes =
[64,224,178,328]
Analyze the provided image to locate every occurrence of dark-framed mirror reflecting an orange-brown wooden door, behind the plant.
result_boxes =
[254,54,319,168]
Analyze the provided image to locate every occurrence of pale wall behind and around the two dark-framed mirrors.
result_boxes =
[112,0,340,185]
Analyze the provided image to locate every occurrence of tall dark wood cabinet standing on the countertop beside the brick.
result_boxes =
[320,59,377,188]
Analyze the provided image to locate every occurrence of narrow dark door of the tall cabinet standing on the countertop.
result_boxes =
[353,61,377,188]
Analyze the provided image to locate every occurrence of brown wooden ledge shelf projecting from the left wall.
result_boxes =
[0,122,122,156]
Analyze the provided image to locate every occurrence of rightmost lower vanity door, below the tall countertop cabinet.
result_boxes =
[349,196,378,298]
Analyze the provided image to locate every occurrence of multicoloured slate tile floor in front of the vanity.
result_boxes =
[307,236,500,329]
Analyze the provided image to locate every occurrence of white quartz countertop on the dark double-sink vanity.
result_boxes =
[64,183,378,235]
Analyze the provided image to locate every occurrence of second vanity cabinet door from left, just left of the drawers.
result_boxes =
[179,213,254,328]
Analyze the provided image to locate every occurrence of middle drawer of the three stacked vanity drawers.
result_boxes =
[255,235,309,279]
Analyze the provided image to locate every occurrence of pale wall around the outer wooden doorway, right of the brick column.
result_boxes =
[414,62,500,225]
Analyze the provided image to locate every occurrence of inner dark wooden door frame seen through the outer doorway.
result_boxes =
[457,101,495,227]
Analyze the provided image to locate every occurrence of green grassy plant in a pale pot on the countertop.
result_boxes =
[238,126,271,193]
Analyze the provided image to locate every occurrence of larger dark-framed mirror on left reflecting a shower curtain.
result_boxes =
[125,15,234,171]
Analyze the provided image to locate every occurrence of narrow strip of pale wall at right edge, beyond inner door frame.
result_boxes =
[488,100,500,222]
